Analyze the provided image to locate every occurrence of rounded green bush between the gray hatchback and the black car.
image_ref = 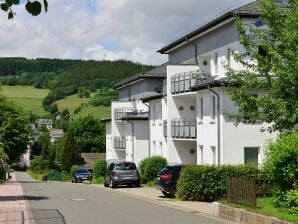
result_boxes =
[139,156,168,183]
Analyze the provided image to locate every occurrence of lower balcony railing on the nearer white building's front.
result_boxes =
[171,118,197,139]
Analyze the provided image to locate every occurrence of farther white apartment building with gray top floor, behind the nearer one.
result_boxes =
[104,64,166,164]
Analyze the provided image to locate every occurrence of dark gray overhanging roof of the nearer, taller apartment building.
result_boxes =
[157,1,261,54]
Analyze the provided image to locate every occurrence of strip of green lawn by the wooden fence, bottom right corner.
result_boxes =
[221,197,298,224]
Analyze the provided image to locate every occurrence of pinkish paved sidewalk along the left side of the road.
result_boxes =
[0,173,30,224]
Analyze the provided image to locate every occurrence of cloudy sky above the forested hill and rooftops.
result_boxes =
[0,0,252,65]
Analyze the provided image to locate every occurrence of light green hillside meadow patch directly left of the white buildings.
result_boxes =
[55,94,111,118]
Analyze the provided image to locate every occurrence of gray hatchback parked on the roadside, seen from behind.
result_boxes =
[104,161,141,188]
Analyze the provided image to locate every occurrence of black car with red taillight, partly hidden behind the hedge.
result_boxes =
[155,165,183,198]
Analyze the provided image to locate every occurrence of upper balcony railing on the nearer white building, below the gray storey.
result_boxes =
[171,71,212,94]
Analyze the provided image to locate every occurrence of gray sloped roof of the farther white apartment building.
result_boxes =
[114,63,167,89]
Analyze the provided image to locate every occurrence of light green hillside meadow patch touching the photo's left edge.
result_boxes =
[0,86,50,117]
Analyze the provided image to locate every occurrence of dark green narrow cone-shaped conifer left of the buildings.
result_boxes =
[60,127,80,171]
